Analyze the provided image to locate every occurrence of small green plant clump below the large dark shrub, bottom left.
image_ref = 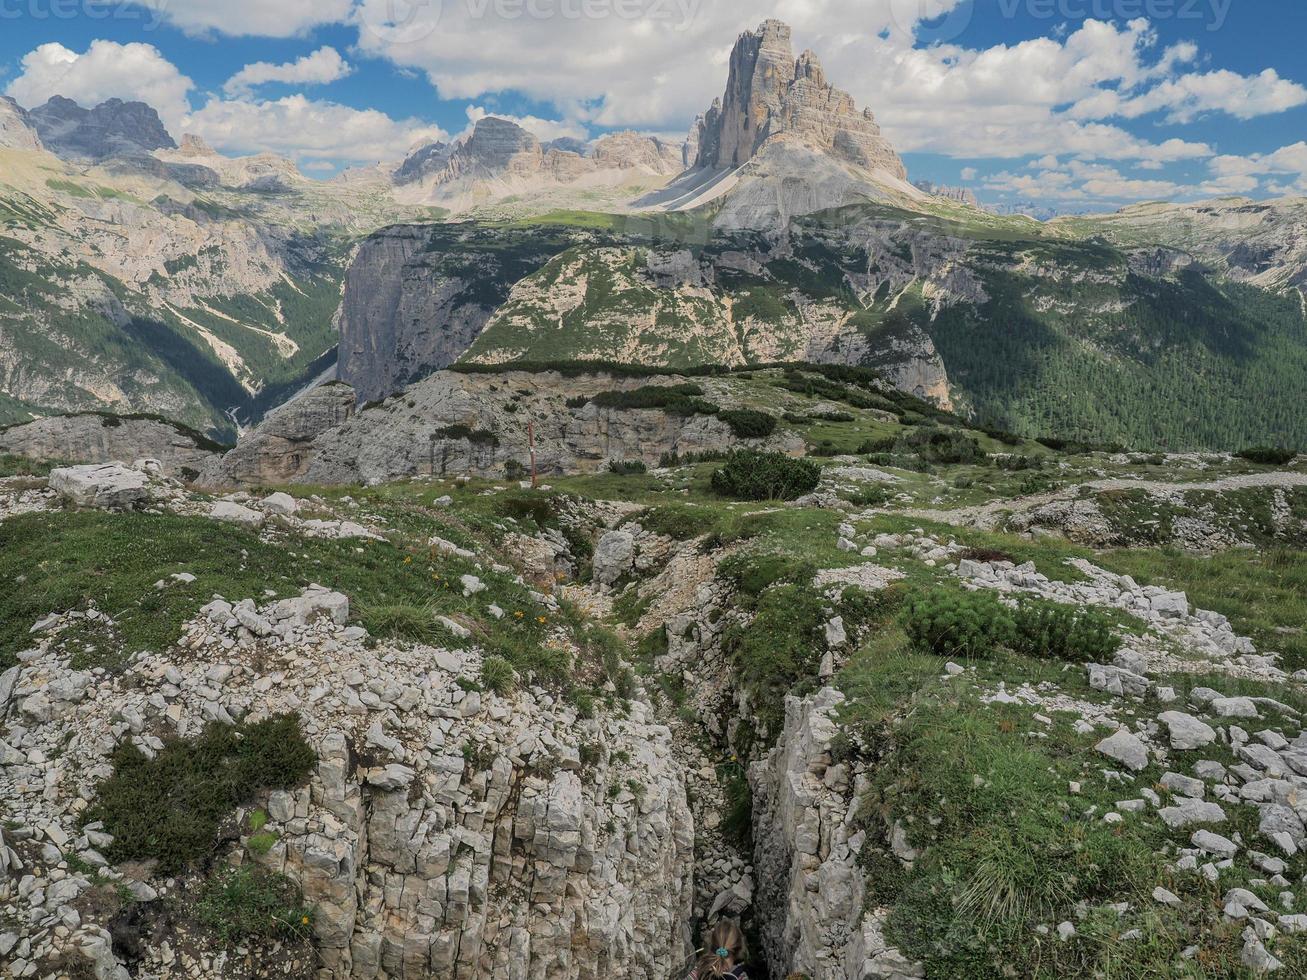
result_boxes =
[195,865,314,946]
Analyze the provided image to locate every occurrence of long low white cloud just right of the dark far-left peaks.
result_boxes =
[186,95,446,163]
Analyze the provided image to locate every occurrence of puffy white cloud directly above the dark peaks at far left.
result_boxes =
[5,41,195,133]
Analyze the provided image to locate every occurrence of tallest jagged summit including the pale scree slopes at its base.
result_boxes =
[640,20,924,229]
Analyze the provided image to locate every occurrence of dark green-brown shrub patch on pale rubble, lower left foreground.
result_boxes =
[85,715,316,874]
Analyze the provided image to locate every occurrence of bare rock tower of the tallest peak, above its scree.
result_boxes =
[690,20,907,180]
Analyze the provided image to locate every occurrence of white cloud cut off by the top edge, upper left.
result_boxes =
[113,0,353,38]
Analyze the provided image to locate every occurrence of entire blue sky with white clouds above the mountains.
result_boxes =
[0,0,1307,210]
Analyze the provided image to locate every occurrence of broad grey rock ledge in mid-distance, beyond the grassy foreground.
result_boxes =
[203,371,802,486]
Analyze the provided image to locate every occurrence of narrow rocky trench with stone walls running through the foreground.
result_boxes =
[592,529,888,980]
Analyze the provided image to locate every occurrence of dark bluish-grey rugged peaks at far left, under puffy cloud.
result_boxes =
[29,95,176,162]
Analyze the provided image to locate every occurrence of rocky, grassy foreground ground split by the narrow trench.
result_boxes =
[0,433,1307,980]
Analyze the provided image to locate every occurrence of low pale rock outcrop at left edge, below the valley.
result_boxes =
[0,413,223,478]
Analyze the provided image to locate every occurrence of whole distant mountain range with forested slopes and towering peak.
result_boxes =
[0,21,1307,448]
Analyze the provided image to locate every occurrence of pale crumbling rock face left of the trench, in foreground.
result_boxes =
[0,591,694,980]
